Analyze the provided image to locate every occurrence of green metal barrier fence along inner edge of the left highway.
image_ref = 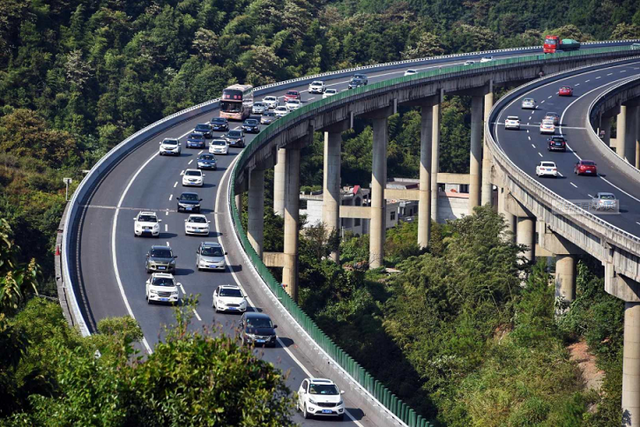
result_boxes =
[227,47,630,427]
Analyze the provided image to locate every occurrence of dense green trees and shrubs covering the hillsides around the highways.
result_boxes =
[0,0,640,427]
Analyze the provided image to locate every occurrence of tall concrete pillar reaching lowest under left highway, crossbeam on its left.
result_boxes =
[282,147,300,301]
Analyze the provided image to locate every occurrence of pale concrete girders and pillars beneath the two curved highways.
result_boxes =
[231,50,640,423]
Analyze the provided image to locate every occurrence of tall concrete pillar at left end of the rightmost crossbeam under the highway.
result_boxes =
[418,106,433,248]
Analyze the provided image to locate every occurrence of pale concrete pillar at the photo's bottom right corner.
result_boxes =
[622,302,640,426]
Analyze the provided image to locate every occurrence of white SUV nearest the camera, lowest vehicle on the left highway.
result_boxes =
[296,378,345,420]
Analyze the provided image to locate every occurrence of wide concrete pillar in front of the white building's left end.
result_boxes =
[322,132,342,262]
